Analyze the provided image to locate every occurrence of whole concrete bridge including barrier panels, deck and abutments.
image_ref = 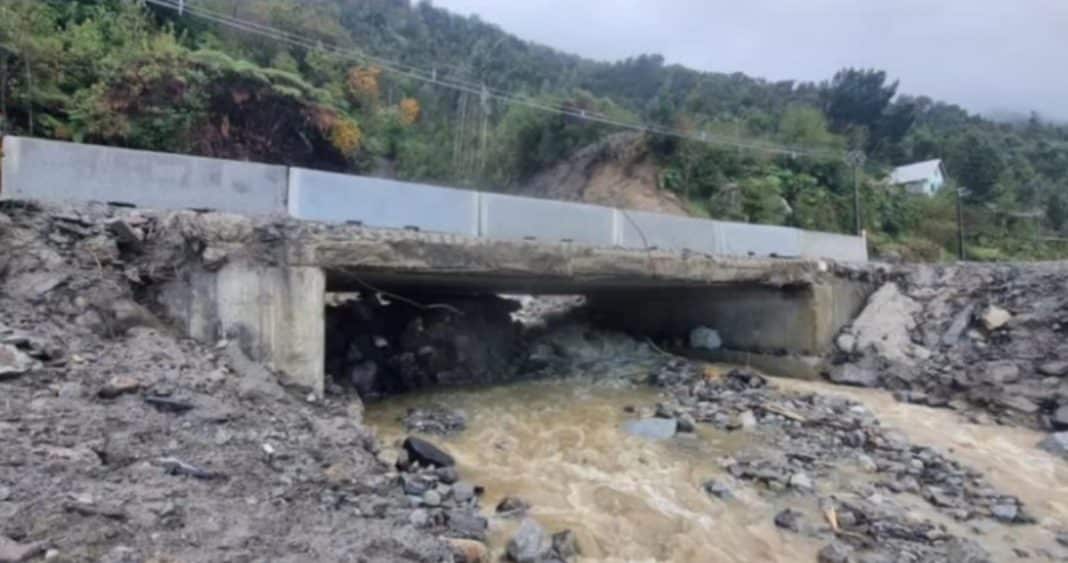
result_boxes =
[0,137,868,391]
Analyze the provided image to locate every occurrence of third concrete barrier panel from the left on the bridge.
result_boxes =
[480,192,616,246]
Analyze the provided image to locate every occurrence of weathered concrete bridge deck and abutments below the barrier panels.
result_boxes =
[161,235,869,392]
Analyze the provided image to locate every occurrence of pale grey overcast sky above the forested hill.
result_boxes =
[434,0,1068,120]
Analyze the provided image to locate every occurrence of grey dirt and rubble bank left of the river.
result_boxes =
[0,205,461,562]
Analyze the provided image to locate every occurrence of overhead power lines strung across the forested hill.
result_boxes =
[143,0,843,158]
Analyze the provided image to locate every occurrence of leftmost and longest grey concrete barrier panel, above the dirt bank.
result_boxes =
[0,137,286,215]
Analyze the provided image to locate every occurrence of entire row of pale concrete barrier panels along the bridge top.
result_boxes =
[0,137,867,262]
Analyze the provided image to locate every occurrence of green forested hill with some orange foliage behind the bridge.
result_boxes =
[0,0,1068,260]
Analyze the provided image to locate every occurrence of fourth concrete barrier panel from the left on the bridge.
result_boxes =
[616,209,720,254]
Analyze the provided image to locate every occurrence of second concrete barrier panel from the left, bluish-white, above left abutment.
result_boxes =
[289,168,478,236]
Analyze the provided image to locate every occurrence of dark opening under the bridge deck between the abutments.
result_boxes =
[313,270,867,400]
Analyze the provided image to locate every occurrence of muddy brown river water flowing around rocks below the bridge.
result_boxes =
[366,371,1068,562]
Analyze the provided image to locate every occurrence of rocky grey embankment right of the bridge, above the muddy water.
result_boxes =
[830,263,1068,455]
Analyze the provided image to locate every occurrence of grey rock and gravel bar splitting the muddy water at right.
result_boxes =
[658,369,1034,561]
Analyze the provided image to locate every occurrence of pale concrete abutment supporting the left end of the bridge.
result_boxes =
[161,263,326,395]
